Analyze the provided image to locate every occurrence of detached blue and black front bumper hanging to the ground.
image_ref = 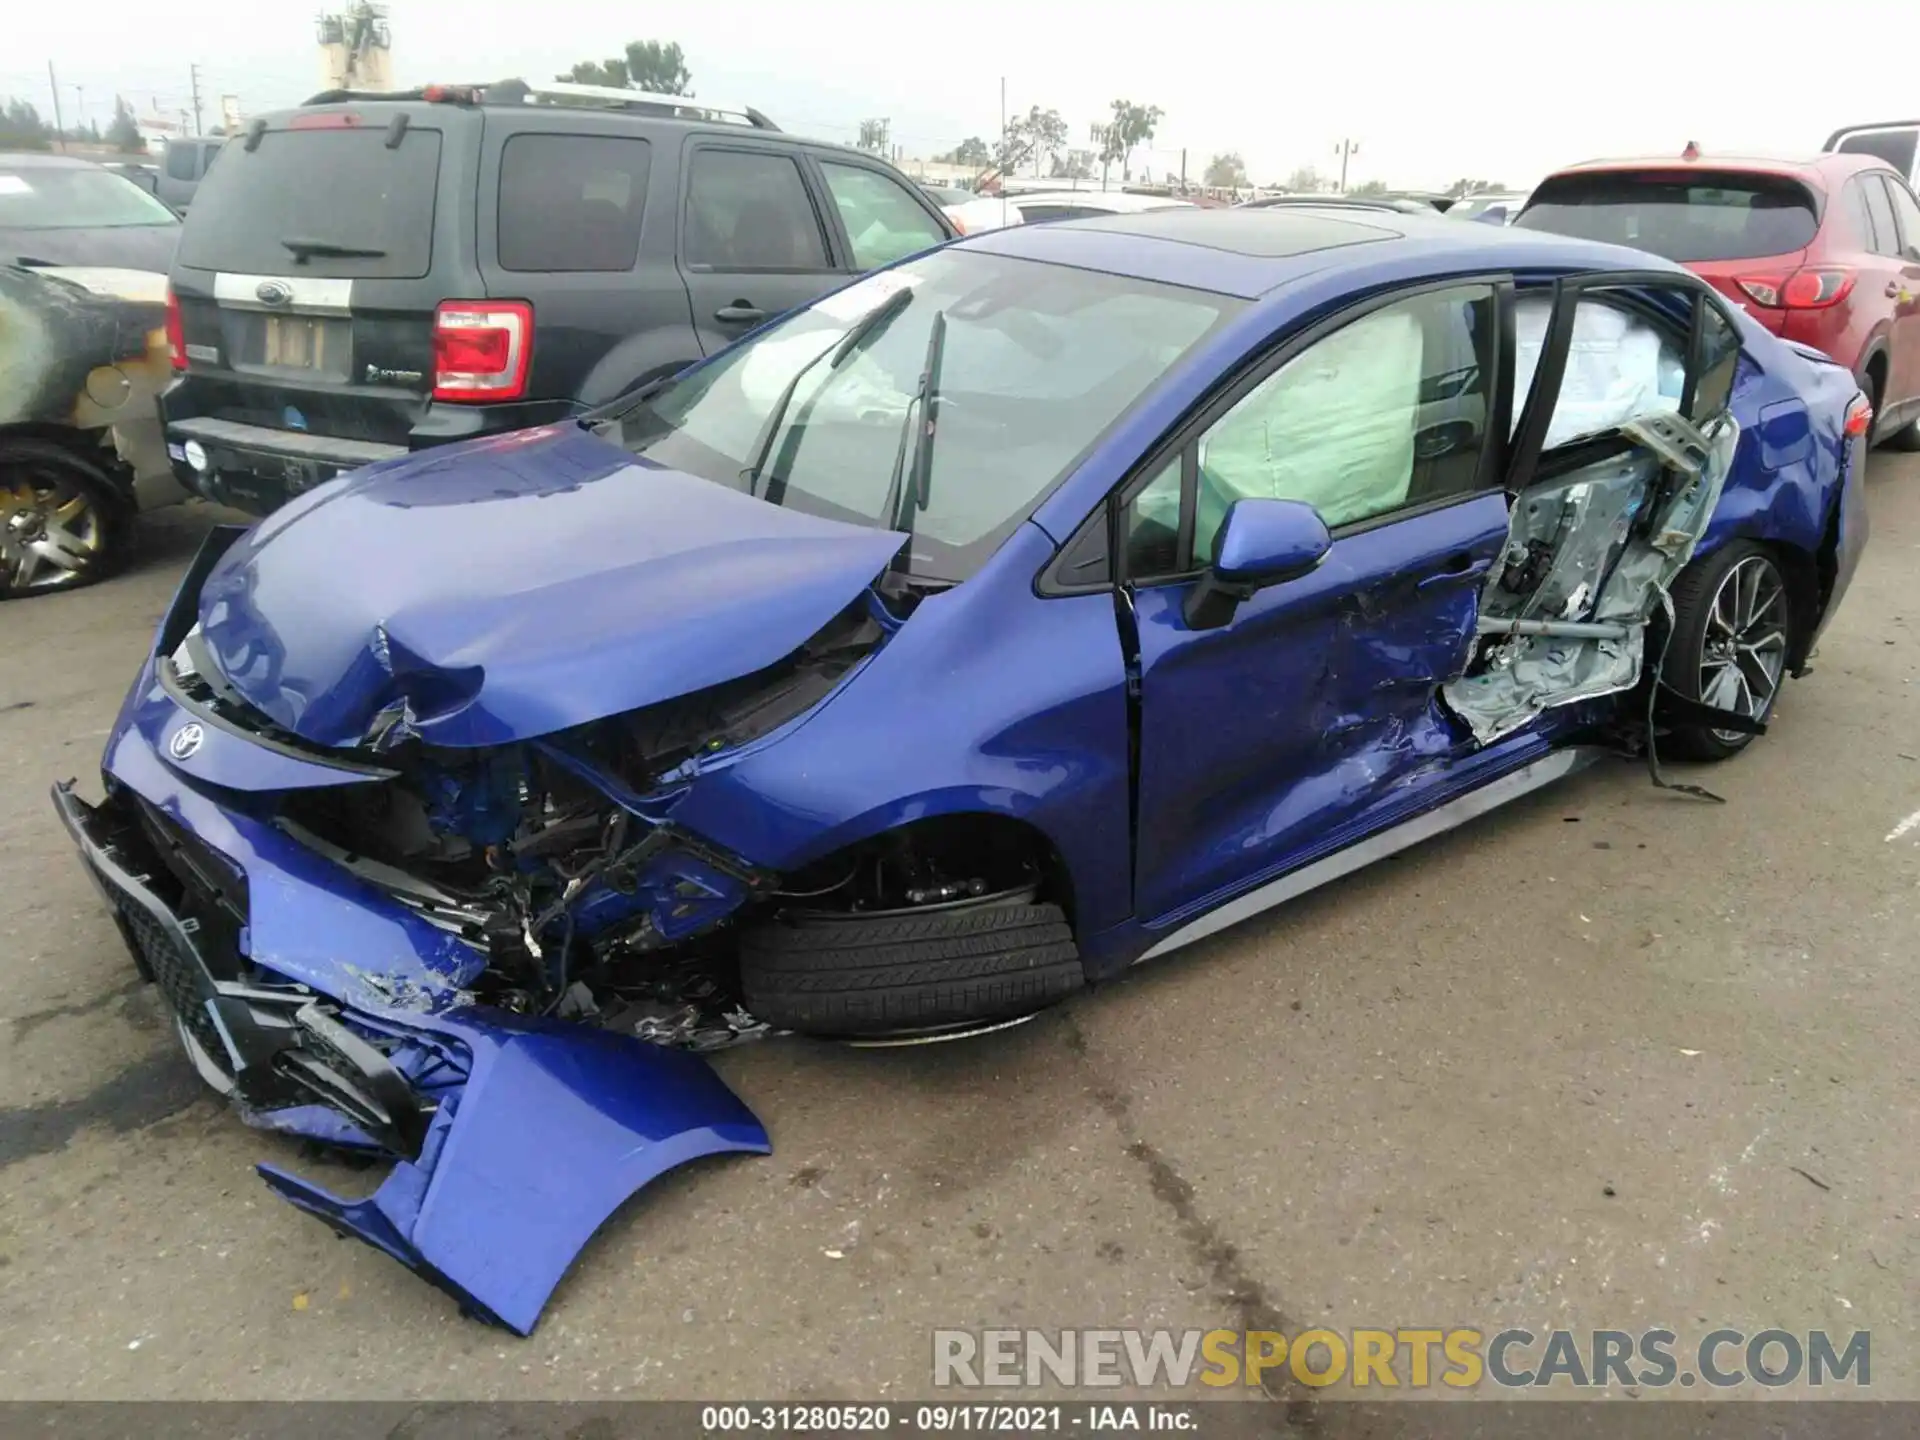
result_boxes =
[54,785,772,1334]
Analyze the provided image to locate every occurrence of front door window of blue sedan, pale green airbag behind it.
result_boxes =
[1192,286,1498,559]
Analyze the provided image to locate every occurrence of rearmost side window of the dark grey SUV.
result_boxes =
[499,134,653,273]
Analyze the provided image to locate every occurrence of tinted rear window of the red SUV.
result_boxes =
[1515,171,1820,261]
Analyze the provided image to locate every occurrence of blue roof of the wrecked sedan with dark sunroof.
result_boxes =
[956,205,1680,300]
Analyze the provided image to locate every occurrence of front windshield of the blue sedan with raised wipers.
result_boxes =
[622,250,1244,580]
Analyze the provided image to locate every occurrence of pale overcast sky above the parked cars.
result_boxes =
[0,0,1920,186]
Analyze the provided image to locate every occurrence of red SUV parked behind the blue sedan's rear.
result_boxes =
[1515,146,1920,449]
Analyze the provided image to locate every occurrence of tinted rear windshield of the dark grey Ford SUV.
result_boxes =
[179,125,440,280]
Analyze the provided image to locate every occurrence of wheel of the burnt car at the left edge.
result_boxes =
[0,438,132,599]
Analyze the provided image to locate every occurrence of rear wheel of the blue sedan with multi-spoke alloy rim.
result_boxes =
[1661,540,1793,760]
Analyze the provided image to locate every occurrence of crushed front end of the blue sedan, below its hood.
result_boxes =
[54,530,887,1334]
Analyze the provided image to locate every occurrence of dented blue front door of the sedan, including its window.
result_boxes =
[1116,278,1511,924]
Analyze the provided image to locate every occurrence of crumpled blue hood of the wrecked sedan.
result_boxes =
[200,422,904,747]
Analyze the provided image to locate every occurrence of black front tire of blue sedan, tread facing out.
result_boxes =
[739,895,1085,1039]
